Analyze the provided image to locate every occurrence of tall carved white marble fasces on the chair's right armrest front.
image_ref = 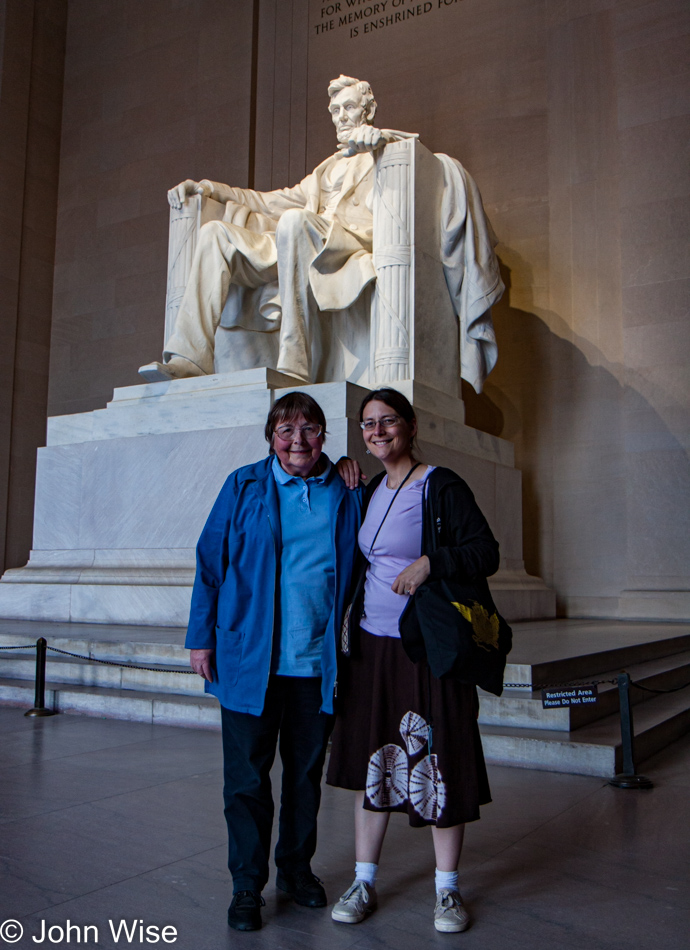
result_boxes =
[372,140,414,384]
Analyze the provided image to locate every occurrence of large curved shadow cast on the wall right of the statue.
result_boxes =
[463,250,690,613]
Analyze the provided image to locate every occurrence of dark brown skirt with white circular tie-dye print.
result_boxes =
[326,629,491,828]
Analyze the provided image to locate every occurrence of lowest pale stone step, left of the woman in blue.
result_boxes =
[0,677,220,729]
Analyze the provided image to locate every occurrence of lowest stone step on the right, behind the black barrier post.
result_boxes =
[480,688,690,778]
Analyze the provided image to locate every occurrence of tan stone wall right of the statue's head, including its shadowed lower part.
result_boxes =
[298,0,690,617]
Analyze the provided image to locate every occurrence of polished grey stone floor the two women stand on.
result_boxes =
[0,708,690,950]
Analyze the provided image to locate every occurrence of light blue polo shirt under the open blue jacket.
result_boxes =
[271,457,335,676]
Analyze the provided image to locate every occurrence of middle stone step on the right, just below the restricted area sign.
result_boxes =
[479,651,690,732]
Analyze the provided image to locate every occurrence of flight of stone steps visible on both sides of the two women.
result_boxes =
[0,621,690,776]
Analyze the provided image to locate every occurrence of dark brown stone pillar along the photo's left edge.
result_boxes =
[0,0,67,570]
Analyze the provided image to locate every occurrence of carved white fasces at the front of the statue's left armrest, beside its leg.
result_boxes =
[163,195,225,345]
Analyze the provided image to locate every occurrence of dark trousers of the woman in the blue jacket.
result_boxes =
[221,676,333,893]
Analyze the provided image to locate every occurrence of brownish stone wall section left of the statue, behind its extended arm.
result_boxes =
[50,0,252,415]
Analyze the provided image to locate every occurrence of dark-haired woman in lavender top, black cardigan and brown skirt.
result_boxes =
[327,389,498,933]
